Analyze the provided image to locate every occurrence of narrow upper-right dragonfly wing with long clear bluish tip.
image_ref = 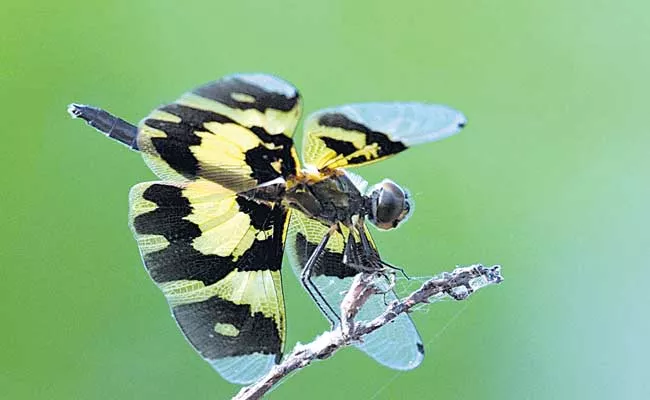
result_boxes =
[302,103,466,170]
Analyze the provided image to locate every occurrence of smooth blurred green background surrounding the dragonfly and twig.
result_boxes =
[0,0,650,399]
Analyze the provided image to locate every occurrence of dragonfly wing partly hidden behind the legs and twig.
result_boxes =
[286,210,424,370]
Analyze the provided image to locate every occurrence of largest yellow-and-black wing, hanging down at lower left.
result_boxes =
[129,179,288,384]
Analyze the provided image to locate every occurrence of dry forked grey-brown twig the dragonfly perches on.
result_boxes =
[233,265,503,400]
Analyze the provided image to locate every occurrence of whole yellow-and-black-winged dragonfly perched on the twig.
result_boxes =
[68,73,466,384]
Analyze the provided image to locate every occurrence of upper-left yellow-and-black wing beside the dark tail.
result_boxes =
[137,74,301,192]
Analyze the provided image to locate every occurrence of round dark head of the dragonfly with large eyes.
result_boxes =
[368,179,413,230]
